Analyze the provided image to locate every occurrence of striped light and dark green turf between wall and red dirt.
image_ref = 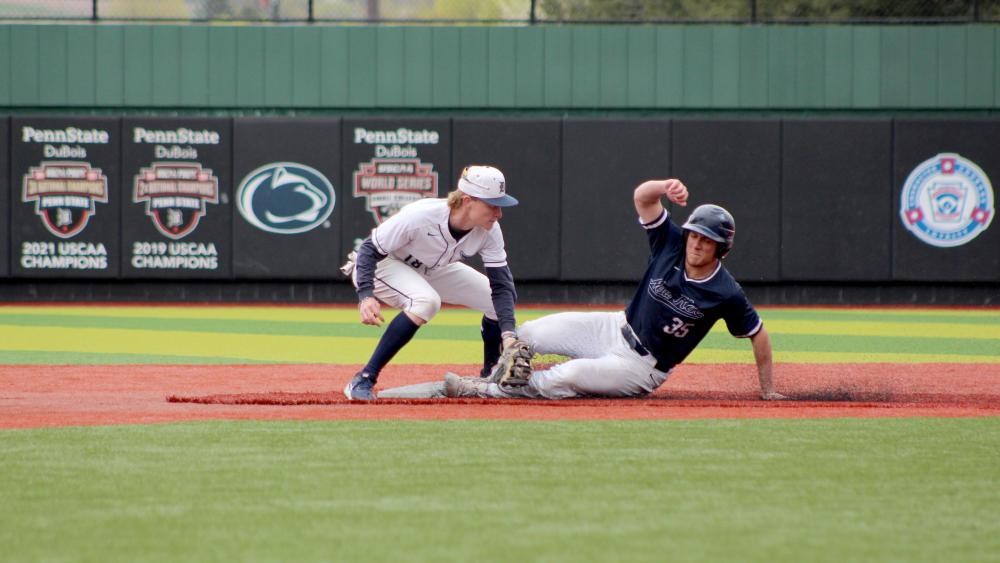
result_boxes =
[0,305,1000,364]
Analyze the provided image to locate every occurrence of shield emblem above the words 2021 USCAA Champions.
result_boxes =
[21,162,108,238]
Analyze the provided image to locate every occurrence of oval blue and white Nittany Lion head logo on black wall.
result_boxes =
[236,162,336,235]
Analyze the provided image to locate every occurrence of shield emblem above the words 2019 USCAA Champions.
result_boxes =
[132,162,219,240]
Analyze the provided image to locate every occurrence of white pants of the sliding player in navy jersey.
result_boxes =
[488,311,669,399]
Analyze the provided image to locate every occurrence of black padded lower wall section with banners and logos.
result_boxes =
[2,115,1000,290]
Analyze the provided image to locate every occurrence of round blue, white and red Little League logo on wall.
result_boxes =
[899,153,995,248]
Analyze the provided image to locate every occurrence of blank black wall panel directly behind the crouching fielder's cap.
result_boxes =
[449,118,561,280]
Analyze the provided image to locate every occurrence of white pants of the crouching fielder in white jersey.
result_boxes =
[360,256,497,322]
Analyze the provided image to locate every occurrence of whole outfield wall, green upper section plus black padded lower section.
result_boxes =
[0,24,1000,303]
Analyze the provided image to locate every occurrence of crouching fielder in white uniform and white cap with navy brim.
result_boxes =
[342,166,517,401]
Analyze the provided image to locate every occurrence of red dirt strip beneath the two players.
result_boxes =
[0,364,1000,428]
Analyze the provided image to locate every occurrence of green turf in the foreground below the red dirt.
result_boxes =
[0,418,1000,562]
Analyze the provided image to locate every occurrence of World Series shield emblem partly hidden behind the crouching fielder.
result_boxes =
[354,158,438,224]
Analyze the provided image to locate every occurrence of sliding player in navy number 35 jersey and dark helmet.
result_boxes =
[444,179,785,400]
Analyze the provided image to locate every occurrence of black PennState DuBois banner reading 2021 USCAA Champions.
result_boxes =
[10,117,120,278]
